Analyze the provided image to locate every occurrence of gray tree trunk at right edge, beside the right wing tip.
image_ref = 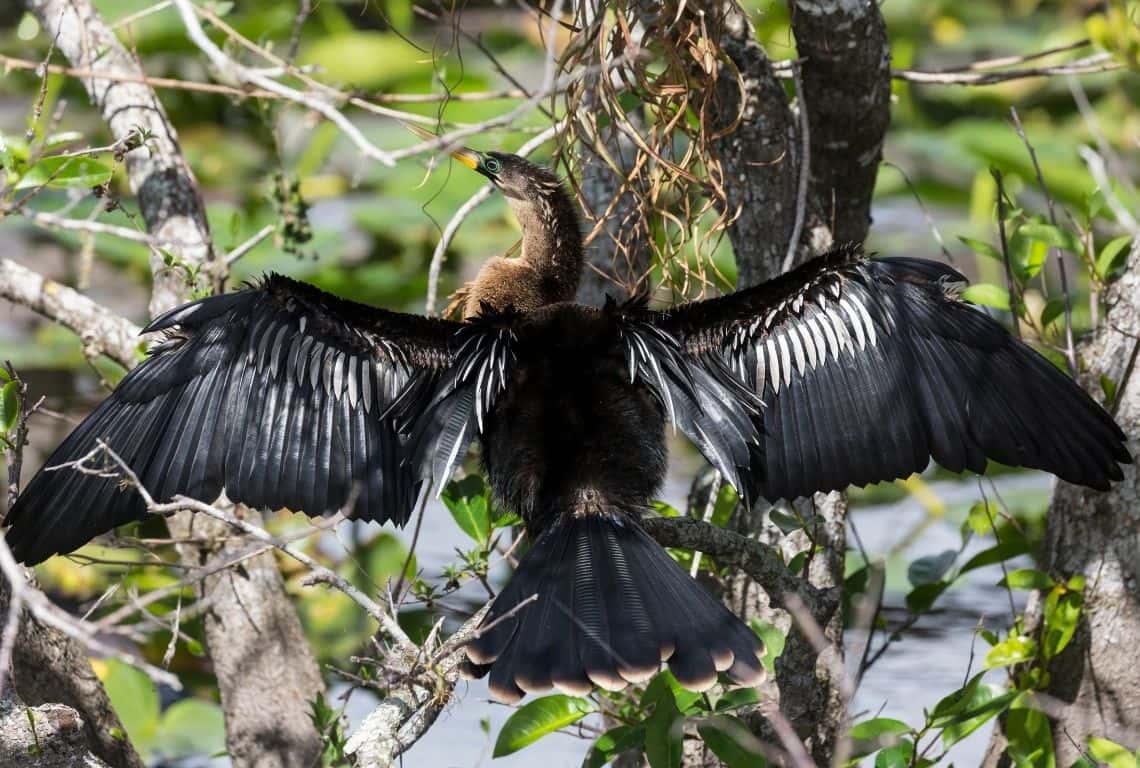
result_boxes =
[985,240,1140,766]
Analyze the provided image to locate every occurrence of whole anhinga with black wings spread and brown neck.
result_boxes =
[6,149,1131,700]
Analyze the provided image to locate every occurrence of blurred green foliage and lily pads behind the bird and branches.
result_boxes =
[0,0,1140,766]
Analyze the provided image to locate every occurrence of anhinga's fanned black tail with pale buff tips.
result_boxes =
[464,514,764,701]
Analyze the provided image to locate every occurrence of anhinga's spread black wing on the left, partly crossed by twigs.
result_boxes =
[5,276,462,563]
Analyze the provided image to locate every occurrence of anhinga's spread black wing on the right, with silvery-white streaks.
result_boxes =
[653,242,1131,500]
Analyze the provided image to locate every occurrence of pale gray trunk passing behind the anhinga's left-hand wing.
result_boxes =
[21,0,323,768]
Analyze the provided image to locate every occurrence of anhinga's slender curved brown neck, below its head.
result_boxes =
[508,187,583,301]
